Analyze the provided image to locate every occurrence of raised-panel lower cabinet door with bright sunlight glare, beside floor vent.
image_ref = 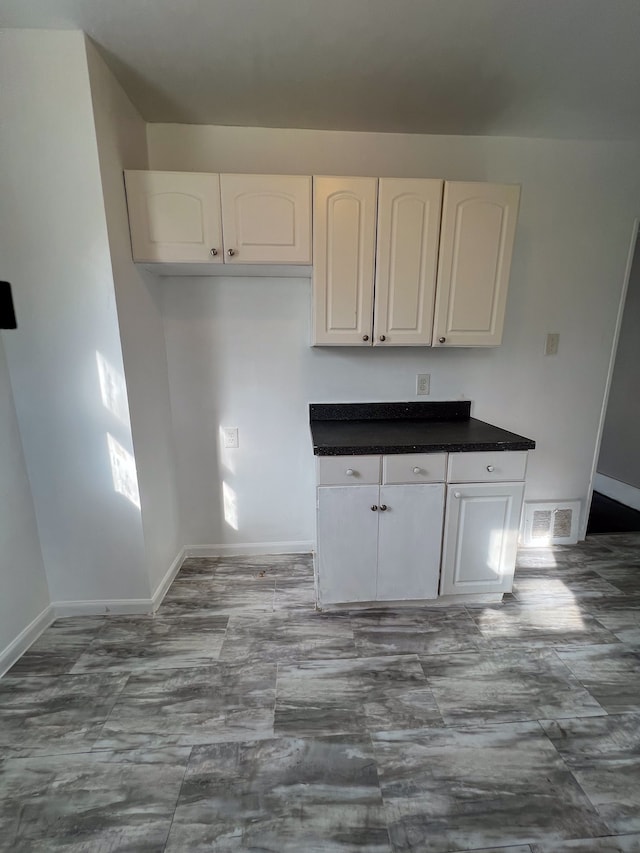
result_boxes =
[440,483,524,595]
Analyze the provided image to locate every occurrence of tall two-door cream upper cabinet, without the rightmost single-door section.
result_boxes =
[313,177,442,346]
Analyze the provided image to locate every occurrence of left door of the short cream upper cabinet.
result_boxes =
[125,172,223,264]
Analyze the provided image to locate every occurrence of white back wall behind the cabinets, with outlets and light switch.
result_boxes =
[147,124,640,545]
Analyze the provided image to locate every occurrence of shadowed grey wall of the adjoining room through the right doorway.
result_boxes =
[598,233,640,489]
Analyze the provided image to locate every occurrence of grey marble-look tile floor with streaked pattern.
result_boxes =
[0,534,640,853]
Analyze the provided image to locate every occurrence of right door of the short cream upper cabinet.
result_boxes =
[220,175,311,264]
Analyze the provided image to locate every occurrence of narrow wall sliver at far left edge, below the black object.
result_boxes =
[0,331,49,674]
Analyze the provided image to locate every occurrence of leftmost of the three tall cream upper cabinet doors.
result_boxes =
[313,177,378,346]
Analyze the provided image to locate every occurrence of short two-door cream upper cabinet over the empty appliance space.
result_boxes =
[125,171,311,265]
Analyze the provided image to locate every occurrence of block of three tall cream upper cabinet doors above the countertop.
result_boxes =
[313,177,520,346]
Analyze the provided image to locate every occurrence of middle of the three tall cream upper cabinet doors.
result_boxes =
[373,178,442,346]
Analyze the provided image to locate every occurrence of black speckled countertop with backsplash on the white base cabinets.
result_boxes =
[309,400,536,456]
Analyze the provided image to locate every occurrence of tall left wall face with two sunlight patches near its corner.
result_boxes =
[0,30,149,601]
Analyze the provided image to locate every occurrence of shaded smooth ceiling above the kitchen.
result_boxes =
[0,0,640,139]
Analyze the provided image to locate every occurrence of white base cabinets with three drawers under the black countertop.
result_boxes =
[316,451,527,607]
